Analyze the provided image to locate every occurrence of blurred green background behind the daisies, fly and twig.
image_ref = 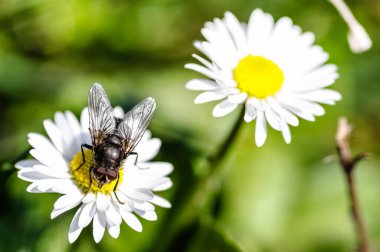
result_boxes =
[0,0,380,252]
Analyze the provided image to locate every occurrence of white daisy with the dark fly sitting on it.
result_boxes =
[16,107,173,243]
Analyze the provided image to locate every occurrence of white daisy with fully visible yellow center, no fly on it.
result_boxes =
[185,9,341,146]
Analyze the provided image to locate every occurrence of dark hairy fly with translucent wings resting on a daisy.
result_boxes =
[77,83,156,202]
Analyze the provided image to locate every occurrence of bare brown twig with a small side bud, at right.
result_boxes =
[335,118,370,252]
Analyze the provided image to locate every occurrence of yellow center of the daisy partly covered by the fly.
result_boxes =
[70,150,123,194]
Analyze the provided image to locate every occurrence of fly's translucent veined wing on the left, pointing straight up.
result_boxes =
[88,83,116,146]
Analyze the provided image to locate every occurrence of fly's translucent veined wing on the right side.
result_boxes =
[118,97,156,155]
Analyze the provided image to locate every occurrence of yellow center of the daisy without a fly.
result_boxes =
[234,55,284,98]
